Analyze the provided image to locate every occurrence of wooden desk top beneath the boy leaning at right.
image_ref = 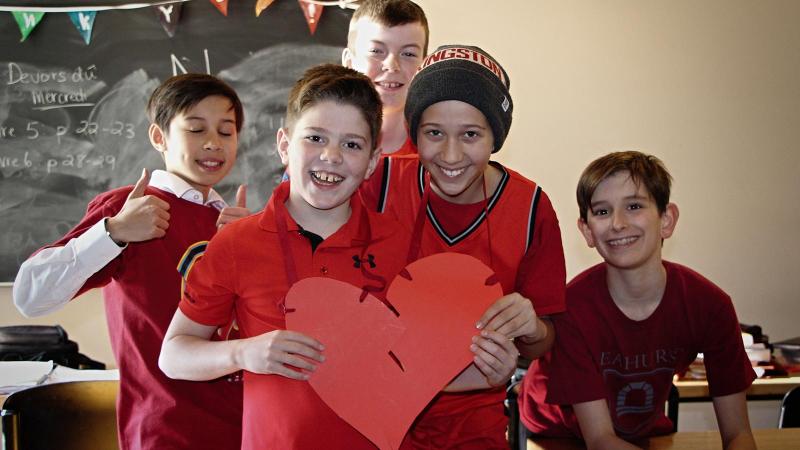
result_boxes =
[528,428,800,450]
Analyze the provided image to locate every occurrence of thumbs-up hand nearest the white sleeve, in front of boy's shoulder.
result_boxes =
[106,169,169,243]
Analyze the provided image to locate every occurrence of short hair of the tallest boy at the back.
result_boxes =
[347,0,430,57]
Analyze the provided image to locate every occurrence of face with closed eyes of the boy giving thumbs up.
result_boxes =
[150,95,238,198]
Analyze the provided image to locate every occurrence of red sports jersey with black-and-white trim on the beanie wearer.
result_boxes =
[361,156,566,449]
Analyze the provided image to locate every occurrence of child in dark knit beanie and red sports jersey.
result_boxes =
[362,46,566,450]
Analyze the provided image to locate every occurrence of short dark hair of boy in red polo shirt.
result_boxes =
[286,64,383,151]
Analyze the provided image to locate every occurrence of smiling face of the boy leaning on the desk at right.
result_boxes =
[578,171,678,270]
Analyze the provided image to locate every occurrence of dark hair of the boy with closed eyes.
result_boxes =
[147,73,244,133]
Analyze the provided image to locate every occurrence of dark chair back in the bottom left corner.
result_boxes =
[2,381,119,450]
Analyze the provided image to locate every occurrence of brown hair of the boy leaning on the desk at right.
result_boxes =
[577,151,672,222]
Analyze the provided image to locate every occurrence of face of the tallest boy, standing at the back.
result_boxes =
[342,17,425,113]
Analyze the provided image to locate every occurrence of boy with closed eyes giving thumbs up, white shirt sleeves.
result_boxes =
[13,74,249,450]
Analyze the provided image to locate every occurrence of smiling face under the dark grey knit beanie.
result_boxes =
[417,100,494,204]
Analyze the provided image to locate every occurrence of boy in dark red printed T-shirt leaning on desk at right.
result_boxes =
[519,151,755,449]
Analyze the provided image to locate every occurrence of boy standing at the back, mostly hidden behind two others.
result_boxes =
[342,0,429,156]
